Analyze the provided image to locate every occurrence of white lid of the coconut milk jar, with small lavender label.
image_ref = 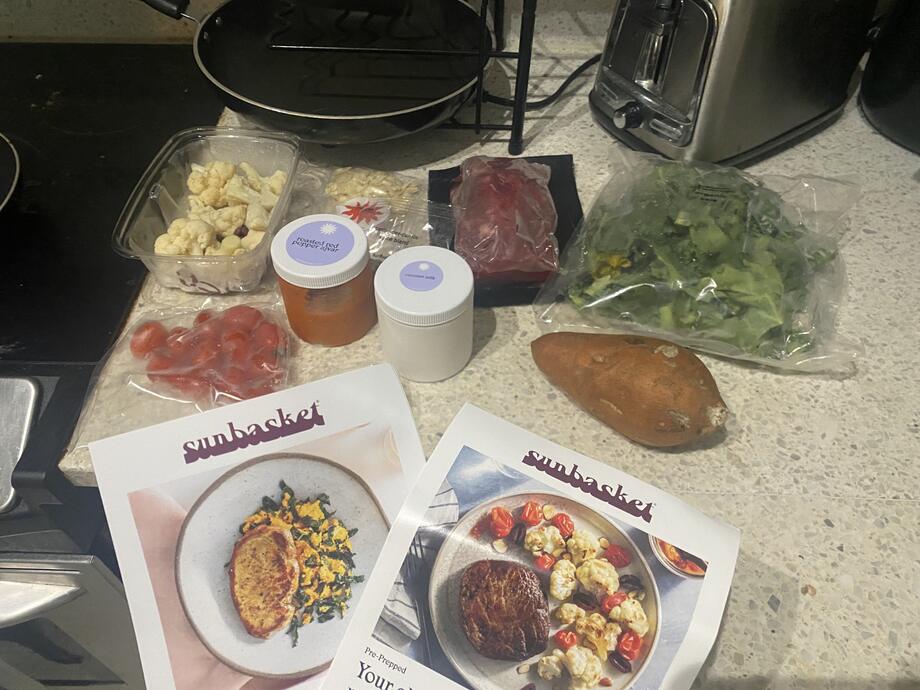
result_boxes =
[374,247,473,326]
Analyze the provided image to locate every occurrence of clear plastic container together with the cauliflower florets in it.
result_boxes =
[113,127,300,294]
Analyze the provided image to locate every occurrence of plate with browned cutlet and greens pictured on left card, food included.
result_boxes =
[176,453,389,678]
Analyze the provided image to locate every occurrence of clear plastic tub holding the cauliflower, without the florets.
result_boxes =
[113,127,299,294]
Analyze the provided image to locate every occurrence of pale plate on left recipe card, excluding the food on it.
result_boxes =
[176,453,388,677]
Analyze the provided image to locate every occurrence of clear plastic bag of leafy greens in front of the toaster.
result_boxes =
[536,153,859,373]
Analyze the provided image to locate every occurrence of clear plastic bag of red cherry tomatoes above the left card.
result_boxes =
[67,296,296,477]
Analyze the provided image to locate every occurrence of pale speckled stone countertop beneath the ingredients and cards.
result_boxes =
[61,52,920,690]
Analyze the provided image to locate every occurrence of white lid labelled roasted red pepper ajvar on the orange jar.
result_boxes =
[272,213,369,290]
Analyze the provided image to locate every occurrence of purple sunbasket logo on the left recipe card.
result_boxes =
[182,402,326,465]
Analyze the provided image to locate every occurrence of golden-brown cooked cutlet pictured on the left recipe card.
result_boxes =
[230,525,300,639]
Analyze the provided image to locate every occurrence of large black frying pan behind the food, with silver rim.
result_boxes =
[144,0,492,144]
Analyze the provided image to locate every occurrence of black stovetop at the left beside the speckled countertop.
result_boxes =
[0,43,222,548]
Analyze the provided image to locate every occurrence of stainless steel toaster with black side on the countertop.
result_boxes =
[590,0,876,164]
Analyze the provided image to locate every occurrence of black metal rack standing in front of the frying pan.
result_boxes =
[269,0,537,156]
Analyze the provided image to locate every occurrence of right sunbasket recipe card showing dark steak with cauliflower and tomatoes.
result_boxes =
[323,405,740,690]
